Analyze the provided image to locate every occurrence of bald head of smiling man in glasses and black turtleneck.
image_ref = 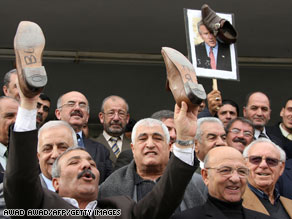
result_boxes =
[202,146,248,202]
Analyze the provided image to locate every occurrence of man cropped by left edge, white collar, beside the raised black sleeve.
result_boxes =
[0,96,19,183]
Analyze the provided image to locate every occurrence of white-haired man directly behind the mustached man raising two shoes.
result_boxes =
[37,121,78,191]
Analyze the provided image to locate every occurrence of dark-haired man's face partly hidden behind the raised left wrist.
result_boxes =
[37,93,51,127]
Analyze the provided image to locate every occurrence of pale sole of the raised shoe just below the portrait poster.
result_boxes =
[162,47,206,105]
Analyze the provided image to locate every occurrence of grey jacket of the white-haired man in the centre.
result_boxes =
[99,160,208,210]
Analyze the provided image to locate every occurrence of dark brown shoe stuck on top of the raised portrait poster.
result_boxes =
[201,4,237,44]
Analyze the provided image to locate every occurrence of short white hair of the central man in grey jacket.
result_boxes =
[131,118,170,144]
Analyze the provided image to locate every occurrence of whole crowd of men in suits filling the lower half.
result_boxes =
[0,15,292,219]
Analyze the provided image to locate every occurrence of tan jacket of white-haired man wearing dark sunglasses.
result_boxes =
[242,186,292,218]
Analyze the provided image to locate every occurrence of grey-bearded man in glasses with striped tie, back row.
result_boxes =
[96,96,131,164]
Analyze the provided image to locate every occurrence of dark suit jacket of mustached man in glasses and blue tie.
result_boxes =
[82,135,113,184]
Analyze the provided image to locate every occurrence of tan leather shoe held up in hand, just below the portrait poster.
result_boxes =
[161,47,206,110]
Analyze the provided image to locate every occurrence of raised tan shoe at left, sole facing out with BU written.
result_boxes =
[14,21,48,97]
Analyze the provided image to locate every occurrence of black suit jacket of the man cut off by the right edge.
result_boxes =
[266,124,292,159]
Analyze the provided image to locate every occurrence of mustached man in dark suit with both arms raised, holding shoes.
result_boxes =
[4,84,198,219]
